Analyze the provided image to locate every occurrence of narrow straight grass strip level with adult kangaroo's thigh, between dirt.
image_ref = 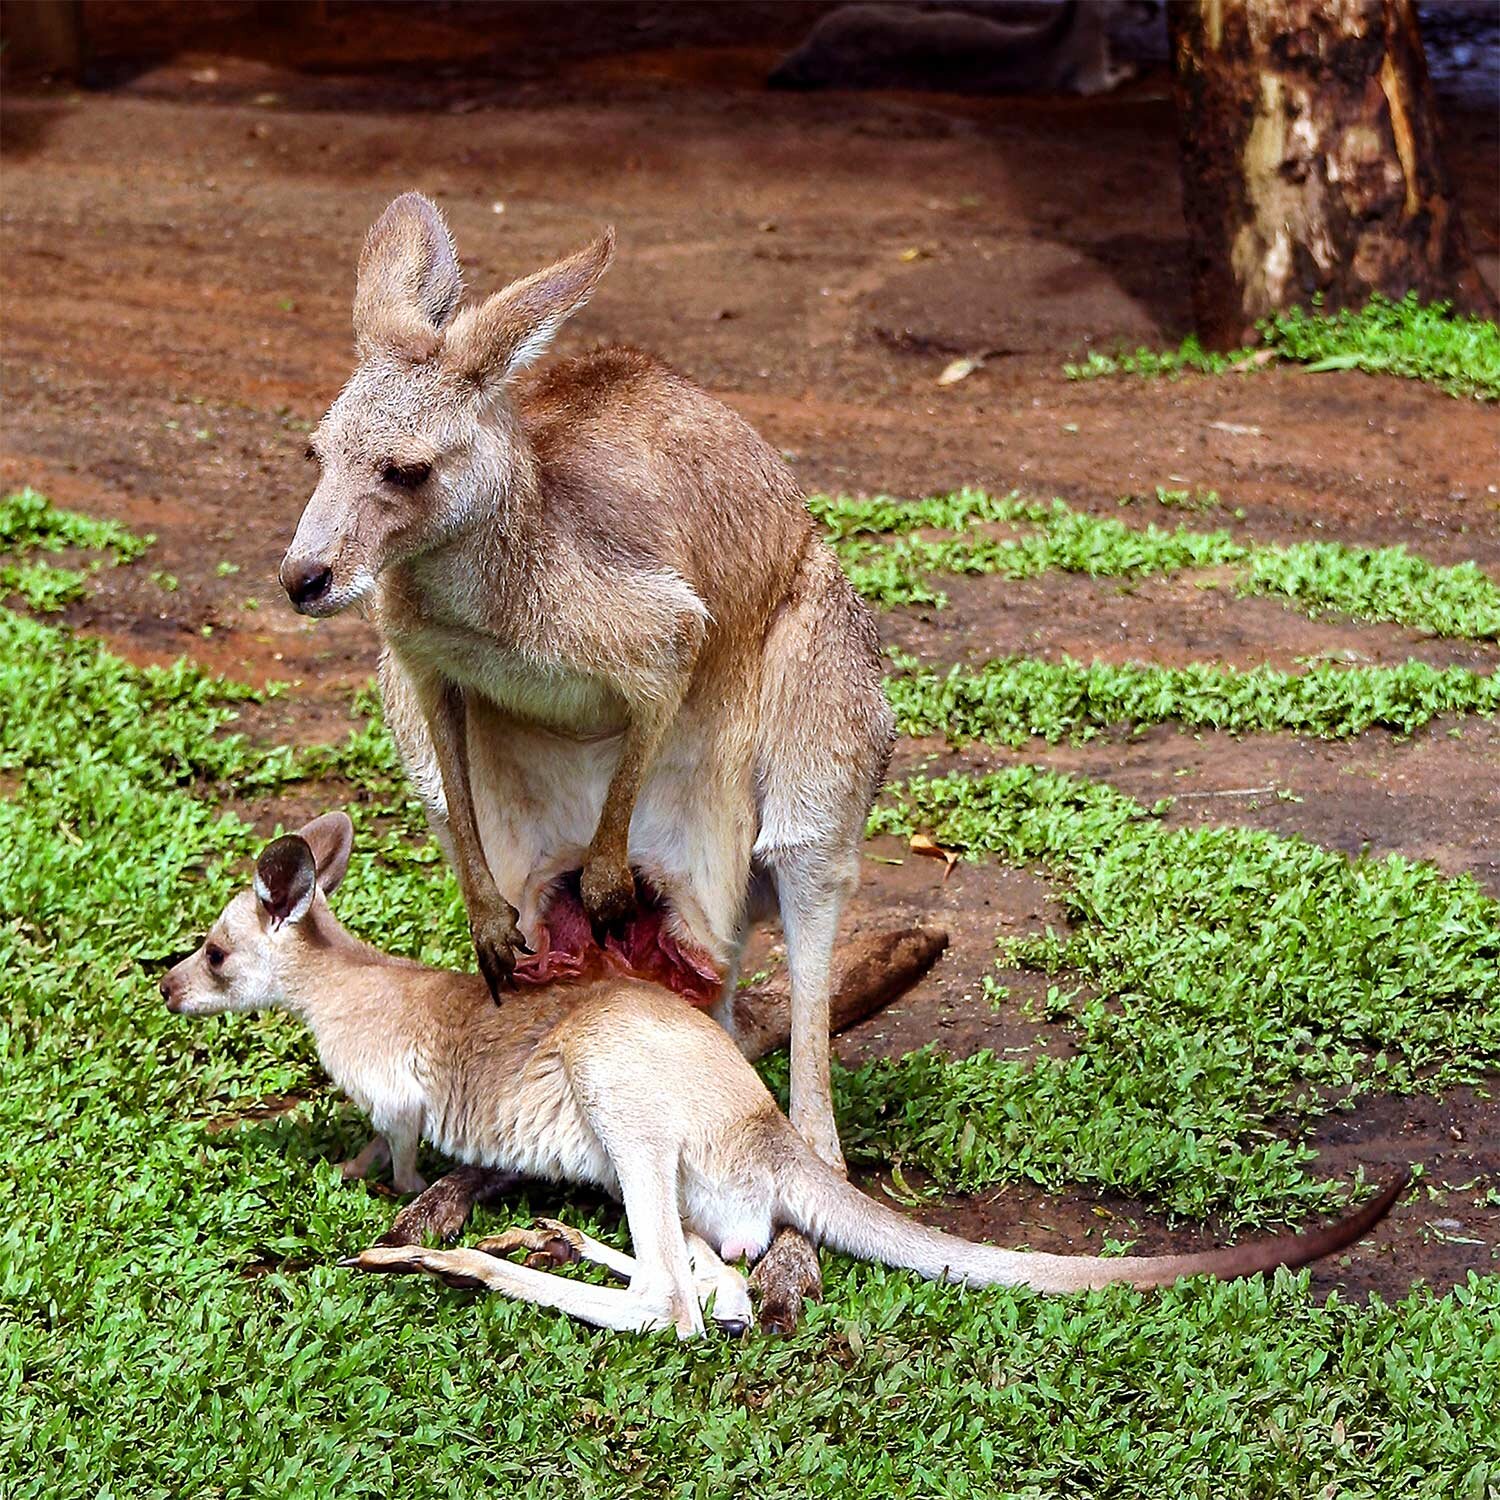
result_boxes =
[885,657,1500,747]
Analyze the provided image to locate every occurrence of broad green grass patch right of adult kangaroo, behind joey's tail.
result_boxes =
[858,767,1500,1221]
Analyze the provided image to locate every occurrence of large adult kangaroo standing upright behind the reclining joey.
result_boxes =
[281,194,893,1167]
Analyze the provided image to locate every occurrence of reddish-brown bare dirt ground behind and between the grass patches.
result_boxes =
[0,3,1500,1293]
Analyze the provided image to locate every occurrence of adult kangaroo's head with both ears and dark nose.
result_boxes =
[281,192,615,615]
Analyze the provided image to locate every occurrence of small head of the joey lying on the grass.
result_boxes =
[161,813,354,1016]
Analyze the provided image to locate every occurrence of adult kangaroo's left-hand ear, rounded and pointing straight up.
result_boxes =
[354,192,464,363]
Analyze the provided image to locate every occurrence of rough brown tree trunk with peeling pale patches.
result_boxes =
[1167,0,1496,348]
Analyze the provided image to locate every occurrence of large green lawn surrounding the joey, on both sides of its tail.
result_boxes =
[0,501,1500,1500]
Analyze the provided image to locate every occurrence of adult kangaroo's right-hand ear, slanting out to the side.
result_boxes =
[443,230,615,380]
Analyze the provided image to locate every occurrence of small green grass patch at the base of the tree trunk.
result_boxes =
[1064,294,1500,401]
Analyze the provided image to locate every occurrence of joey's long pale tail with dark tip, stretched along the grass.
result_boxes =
[782,1143,1410,1292]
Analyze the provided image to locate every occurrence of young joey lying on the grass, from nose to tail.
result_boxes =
[162,813,1406,1337]
